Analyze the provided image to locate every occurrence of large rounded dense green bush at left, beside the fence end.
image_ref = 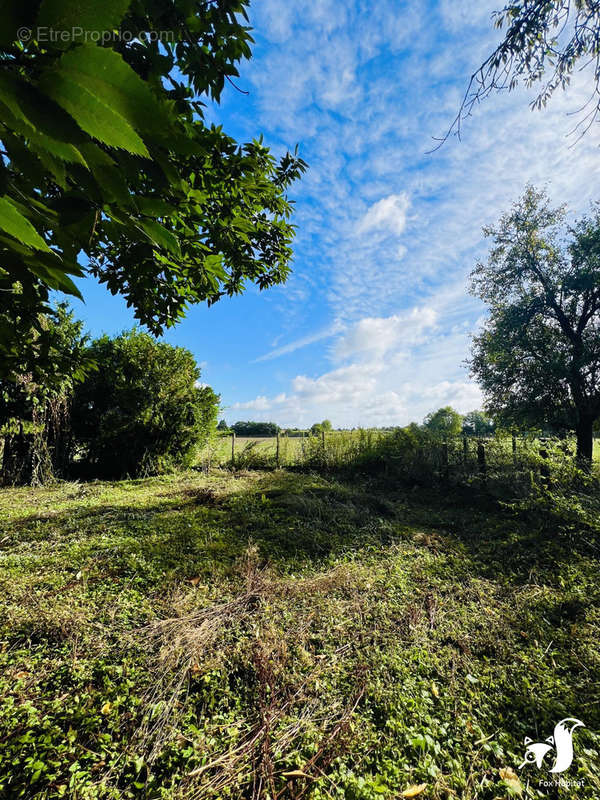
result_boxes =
[72,329,219,477]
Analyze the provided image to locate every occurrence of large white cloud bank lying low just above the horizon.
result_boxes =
[227,296,481,427]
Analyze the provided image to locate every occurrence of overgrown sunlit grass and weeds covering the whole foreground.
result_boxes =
[0,470,600,800]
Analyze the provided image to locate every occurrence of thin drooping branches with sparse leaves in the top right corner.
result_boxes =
[444,0,600,140]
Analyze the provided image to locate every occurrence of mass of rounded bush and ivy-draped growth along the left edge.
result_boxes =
[0,324,219,485]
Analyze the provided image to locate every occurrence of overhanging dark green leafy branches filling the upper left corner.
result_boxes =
[0,0,306,374]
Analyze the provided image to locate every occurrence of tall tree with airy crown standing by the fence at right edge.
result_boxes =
[471,186,600,464]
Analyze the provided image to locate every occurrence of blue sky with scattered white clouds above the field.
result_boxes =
[74,0,600,427]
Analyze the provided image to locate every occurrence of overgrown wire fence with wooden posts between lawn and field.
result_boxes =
[198,428,596,494]
